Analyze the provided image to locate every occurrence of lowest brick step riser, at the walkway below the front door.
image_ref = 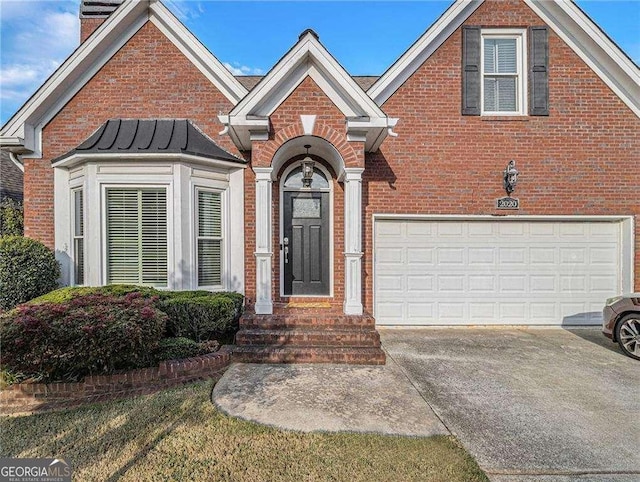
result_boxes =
[231,350,386,365]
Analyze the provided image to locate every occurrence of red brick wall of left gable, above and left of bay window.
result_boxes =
[25,22,240,247]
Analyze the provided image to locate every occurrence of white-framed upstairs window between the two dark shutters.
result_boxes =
[481,29,527,115]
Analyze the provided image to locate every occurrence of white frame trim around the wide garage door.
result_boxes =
[371,213,636,326]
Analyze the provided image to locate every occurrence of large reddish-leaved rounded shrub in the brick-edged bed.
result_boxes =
[0,292,167,380]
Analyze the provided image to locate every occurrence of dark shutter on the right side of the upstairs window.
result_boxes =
[529,27,549,115]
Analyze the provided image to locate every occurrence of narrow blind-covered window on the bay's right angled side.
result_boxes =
[197,191,222,286]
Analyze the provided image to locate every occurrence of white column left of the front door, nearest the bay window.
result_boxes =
[253,167,273,315]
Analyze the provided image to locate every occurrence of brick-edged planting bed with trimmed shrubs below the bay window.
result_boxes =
[0,285,243,413]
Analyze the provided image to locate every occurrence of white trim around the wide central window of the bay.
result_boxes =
[99,183,174,290]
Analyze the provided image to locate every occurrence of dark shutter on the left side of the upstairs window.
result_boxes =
[462,27,481,115]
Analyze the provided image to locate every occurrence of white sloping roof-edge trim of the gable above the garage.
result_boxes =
[367,0,640,117]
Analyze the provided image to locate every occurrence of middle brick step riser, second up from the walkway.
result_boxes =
[236,331,380,348]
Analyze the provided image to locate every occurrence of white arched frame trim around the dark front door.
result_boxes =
[278,161,335,298]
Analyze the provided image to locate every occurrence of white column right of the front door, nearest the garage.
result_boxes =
[344,167,364,315]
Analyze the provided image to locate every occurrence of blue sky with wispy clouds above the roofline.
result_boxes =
[0,0,640,124]
